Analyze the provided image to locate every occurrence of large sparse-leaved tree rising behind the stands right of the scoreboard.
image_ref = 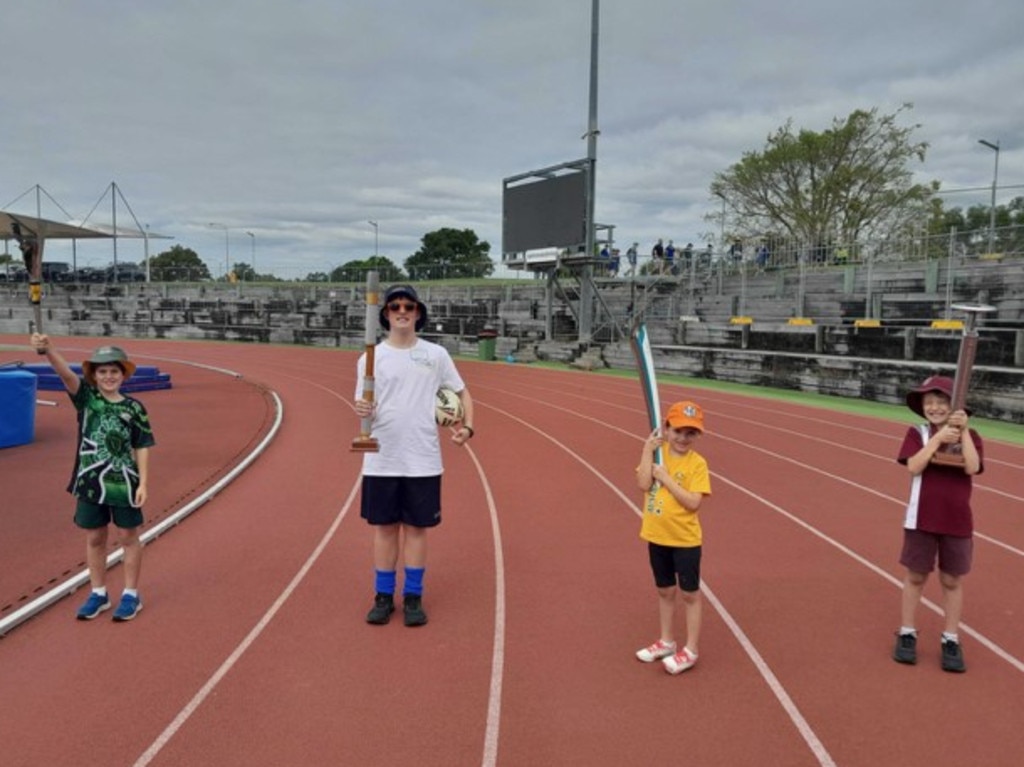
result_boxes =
[711,104,936,247]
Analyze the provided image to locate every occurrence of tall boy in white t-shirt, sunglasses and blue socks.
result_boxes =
[355,285,473,626]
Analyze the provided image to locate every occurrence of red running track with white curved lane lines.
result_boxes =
[0,339,1024,767]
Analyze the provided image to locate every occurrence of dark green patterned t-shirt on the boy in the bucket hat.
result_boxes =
[68,380,156,506]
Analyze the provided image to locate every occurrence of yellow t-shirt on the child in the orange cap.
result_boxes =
[640,448,711,547]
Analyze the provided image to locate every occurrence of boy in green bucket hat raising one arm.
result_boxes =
[32,333,156,622]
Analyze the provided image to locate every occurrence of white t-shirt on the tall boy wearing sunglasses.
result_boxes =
[355,339,466,477]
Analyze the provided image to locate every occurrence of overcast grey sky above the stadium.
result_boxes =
[0,0,1024,279]
